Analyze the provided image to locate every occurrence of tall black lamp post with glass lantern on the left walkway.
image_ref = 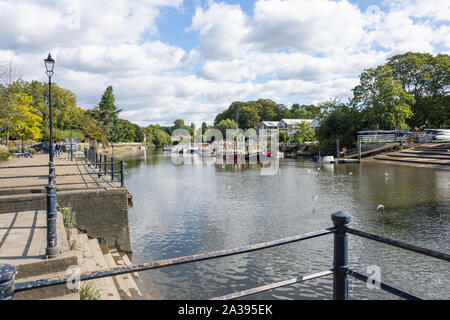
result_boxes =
[44,53,59,258]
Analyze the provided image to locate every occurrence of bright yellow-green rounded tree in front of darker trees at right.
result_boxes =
[352,66,415,129]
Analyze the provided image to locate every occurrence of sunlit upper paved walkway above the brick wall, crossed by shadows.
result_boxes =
[0,154,116,195]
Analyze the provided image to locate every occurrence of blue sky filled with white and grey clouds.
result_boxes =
[0,0,450,126]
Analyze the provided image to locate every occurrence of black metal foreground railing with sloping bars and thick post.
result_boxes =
[0,212,450,300]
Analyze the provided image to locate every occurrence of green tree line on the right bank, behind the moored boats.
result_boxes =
[209,52,450,152]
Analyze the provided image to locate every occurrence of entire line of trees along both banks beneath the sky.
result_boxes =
[0,52,450,151]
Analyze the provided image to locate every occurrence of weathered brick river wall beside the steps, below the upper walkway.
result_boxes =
[0,188,131,252]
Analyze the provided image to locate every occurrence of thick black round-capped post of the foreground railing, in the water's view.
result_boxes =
[331,211,352,300]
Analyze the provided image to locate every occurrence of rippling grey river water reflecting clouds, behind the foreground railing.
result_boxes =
[115,150,450,299]
